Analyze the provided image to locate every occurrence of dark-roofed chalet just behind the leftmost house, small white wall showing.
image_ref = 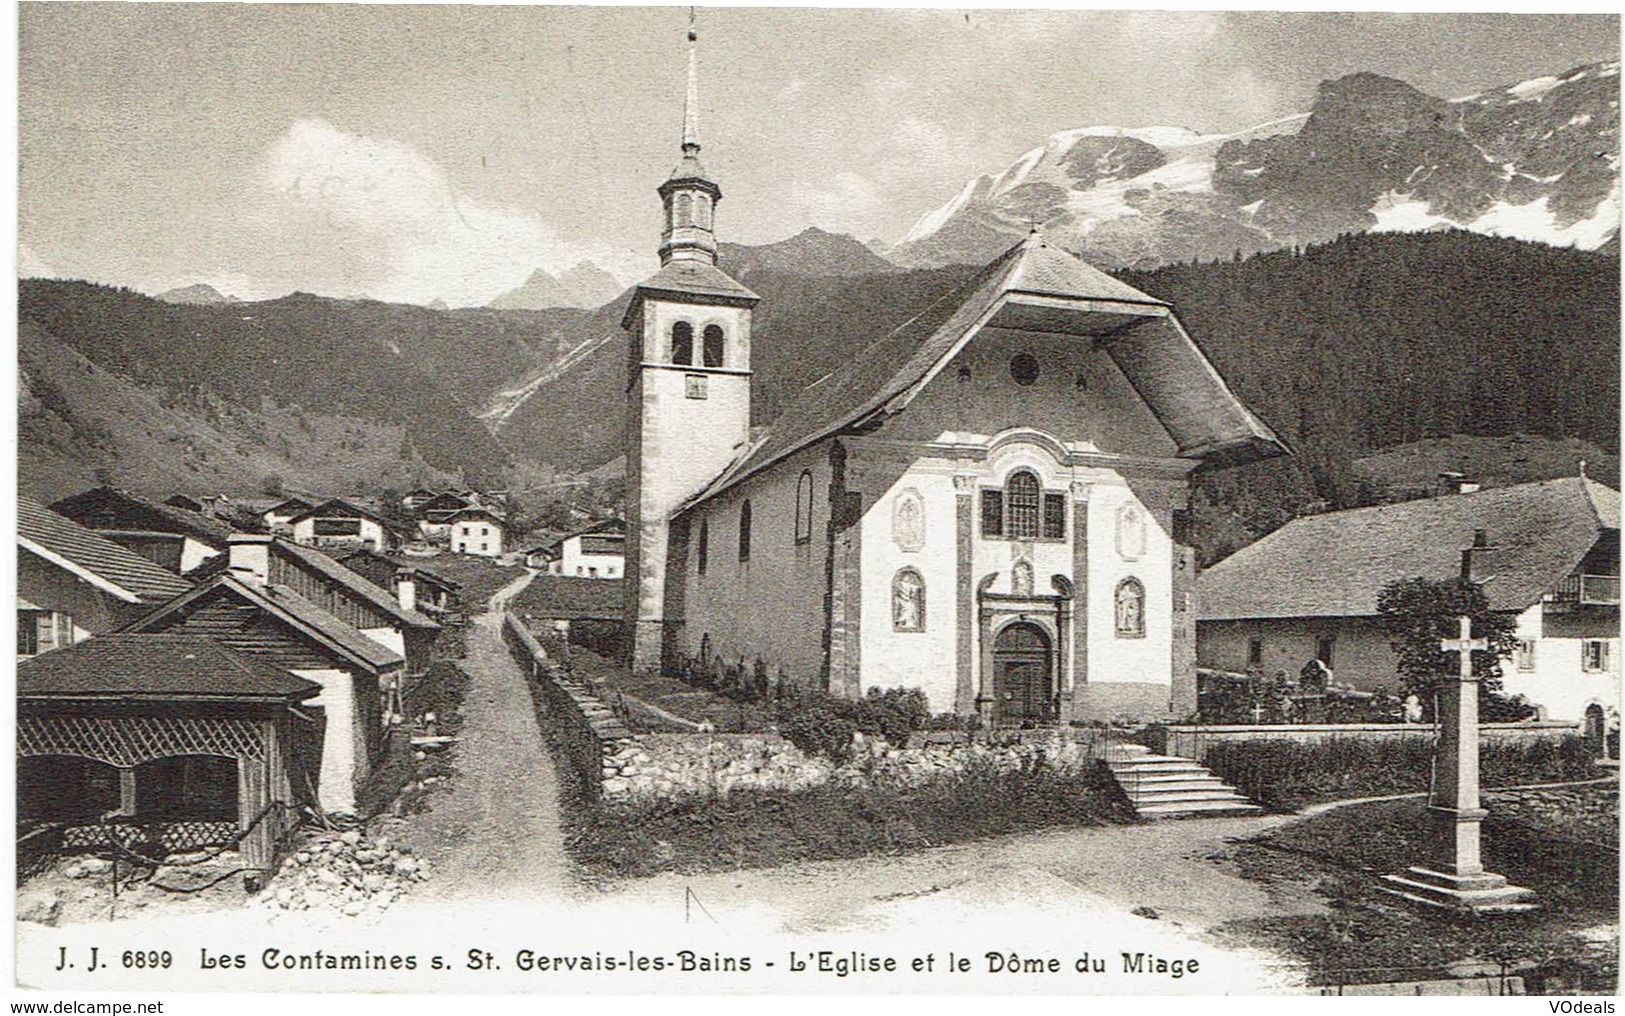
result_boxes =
[50,486,232,574]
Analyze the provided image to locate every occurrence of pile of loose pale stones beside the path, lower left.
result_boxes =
[260,829,429,917]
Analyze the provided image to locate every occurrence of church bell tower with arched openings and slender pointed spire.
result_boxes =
[621,15,759,671]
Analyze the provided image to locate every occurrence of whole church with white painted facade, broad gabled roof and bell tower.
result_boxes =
[622,29,1287,727]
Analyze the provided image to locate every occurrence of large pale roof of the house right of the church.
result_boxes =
[1196,476,1620,621]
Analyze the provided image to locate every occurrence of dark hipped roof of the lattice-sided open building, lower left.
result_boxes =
[16,634,322,702]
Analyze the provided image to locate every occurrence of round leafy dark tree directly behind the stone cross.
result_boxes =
[1376,579,1518,709]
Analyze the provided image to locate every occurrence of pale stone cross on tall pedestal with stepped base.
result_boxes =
[1383,616,1536,914]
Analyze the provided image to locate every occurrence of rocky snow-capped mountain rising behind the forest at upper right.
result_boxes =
[887,62,1620,267]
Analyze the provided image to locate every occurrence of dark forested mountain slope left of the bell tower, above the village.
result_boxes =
[18,280,583,481]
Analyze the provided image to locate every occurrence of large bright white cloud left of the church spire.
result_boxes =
[245,119,580,306]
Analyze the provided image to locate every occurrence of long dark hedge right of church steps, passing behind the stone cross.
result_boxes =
[1203,736,1597,811]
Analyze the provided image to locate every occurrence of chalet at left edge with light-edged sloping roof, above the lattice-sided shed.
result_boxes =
[16,496,190,657]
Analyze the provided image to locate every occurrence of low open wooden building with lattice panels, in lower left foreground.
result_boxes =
[16,634,322,879]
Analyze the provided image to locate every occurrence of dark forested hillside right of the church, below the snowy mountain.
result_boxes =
[1121,231,1620,561]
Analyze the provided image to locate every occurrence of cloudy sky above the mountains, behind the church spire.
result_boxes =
[18,3,1619,306]
